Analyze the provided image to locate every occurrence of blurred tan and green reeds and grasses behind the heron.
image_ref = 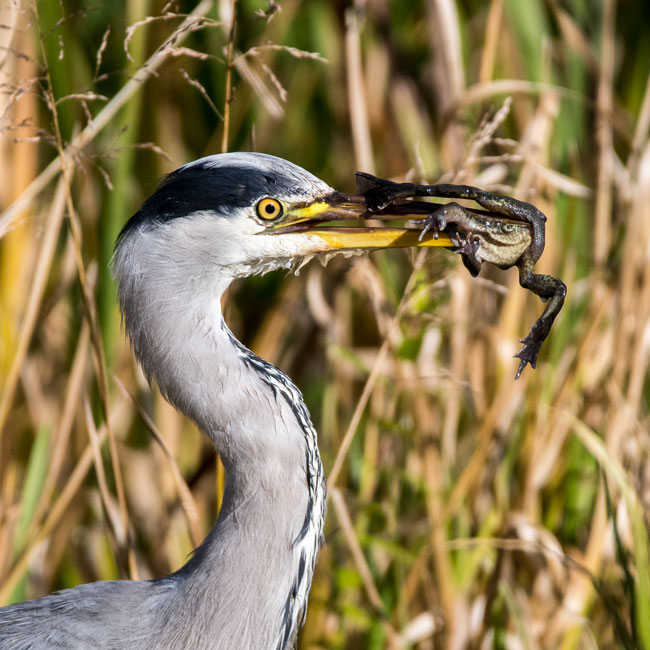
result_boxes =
[0,0,650,650]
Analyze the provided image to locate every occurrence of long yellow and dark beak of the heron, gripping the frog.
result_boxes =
[264,192,454,250]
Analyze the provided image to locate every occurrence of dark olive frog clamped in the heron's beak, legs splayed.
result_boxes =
[356,172,567,379]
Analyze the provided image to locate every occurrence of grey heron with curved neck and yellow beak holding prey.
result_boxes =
[0,153,450,650]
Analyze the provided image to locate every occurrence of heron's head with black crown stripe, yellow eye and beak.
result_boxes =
[115,152,450,282]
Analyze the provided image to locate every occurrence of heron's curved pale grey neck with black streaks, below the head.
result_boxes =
[123,274,325,650]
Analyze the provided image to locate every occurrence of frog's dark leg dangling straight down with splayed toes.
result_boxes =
[515,257,566,379]
